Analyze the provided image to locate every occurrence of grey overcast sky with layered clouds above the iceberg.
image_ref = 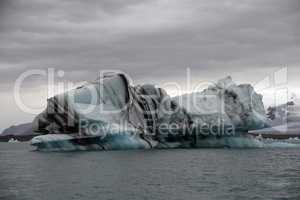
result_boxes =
[0,0,300,130]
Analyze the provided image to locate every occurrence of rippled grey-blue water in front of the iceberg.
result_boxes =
[0,143,300,200]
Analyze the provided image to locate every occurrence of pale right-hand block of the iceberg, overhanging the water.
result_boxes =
[174,77,268,133]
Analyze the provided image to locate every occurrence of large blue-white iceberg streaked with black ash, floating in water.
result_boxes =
[31,74,268,150]
